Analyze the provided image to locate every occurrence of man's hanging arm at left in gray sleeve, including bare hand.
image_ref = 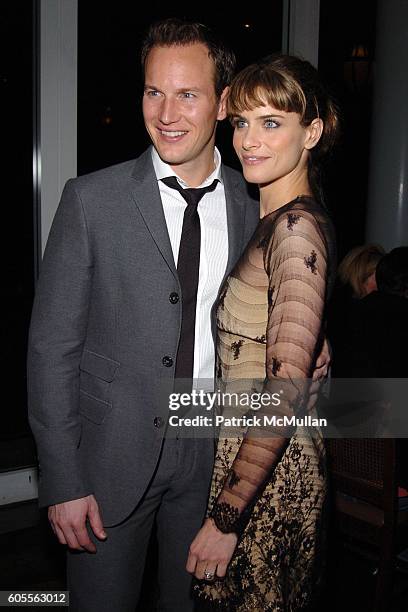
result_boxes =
[28,181,105,547]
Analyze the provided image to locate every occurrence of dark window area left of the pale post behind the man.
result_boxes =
[0,0,34,448]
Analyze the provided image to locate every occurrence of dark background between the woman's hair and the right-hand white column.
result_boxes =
[319,0,376,256]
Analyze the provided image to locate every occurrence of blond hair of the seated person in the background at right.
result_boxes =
[337,244,385,298]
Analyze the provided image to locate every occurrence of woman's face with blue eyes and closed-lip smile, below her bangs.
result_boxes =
[232,104,322,185]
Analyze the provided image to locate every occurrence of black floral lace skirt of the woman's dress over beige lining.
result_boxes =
[195,434,326,612]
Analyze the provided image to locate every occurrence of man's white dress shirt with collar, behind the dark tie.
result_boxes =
[152,148,228,381]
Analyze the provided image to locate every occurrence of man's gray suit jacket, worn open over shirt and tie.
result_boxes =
[28,150,259,525]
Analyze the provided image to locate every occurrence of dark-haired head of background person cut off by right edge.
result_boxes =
[375,247,408,298]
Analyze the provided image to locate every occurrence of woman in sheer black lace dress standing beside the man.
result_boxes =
[187,56,338,612]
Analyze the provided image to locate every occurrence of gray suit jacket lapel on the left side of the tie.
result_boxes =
[132,148,178,278]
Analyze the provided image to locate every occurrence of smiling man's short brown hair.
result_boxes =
[141,18,236,98]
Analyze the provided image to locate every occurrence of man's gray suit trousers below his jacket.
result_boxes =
[67,434,214,612]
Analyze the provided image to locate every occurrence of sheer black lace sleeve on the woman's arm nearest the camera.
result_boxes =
[210,204,328,533]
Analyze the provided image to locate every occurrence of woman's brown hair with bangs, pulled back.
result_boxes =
[227,54,340,200]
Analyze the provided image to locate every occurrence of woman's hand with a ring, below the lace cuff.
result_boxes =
[186,519,238,580]
